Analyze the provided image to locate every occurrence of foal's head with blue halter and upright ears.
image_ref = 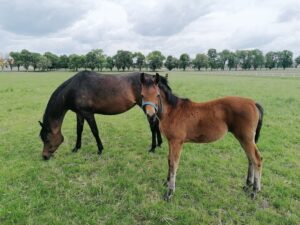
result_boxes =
[141,73,161,122]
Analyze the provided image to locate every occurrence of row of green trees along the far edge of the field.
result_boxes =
[0,48,300,71]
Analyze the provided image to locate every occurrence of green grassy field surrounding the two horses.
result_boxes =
[0,71,300,225]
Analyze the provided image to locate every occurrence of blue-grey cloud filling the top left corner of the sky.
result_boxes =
[0,0,87,36]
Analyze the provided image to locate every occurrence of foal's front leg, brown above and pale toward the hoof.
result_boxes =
[164,141,183,201]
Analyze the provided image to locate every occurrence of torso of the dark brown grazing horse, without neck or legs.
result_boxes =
[68,71,140,115]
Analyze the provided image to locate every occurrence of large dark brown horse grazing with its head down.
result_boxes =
[40,71,162,160]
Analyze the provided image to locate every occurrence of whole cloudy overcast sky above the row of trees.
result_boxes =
[0,0,300,57]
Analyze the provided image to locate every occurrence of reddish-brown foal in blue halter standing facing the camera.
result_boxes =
[141,74,263,200]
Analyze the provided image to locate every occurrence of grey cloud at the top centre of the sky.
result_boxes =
[124,0,213,36]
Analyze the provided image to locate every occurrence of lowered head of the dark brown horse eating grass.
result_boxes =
[39,122,64,160]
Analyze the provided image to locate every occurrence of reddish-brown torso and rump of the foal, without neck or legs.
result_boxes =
[177,96,259,143]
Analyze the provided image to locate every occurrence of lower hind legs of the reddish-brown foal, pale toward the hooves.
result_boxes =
[242,141,262,198]
